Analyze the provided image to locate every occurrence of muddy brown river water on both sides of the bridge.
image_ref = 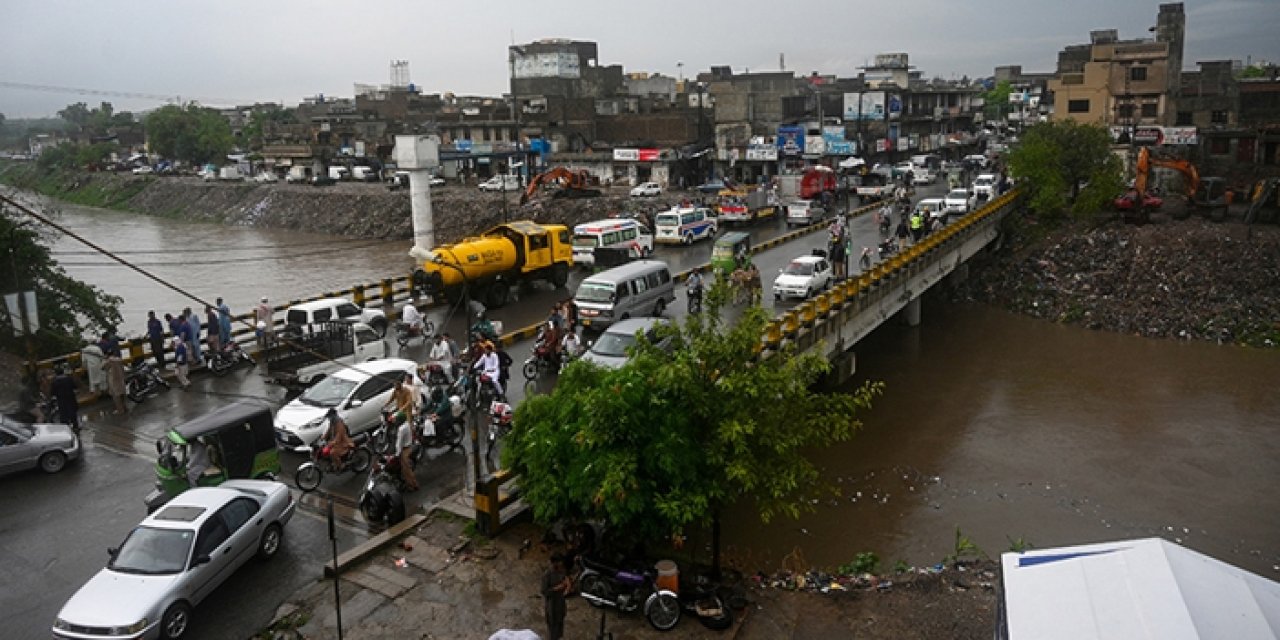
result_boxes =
[40,197,1280,579]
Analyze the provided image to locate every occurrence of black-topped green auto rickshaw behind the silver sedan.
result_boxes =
[146,402,280,513]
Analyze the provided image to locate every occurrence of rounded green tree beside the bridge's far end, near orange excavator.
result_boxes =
[1009,120,1124,218]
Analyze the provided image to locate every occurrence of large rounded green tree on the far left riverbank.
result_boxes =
[143,104,233,165]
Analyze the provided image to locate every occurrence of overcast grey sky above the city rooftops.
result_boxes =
[0,0,1280,118]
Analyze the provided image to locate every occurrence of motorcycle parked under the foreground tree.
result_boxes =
[577,556,681,631]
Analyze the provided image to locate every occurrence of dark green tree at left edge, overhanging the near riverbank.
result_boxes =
[0,200,122,357]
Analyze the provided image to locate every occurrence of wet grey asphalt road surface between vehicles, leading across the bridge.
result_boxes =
[0,184,945,639]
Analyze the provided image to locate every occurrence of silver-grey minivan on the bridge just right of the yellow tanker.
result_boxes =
[573,260,676,329]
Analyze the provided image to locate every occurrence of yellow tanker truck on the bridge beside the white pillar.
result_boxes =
[413,220,573,308]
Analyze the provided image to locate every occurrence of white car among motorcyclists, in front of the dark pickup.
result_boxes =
[275,358,421,453]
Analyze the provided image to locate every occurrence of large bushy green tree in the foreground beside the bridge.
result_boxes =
[503,285,882,568]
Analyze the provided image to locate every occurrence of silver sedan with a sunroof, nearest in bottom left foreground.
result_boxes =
[52,480,293,640]
